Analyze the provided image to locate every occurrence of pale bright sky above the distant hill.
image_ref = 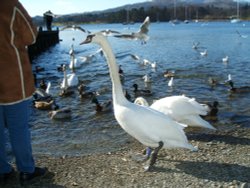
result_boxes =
[19,0,149,17]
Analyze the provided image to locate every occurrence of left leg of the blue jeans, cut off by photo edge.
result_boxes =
[0,105,11,174]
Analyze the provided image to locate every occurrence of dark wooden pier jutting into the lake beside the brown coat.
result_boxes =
[28,29,59,62]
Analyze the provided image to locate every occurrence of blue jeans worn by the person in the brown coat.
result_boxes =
[0,100,35,174]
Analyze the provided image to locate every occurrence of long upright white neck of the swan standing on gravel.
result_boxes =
[97,36,127,104]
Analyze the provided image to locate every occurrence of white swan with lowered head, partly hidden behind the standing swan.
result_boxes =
[134,95,216,130]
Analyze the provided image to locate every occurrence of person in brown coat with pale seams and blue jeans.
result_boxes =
[0,0,46,183]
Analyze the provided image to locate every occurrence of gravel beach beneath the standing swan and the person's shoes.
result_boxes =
[2,125,250,188]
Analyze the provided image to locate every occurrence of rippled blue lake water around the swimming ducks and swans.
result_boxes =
[25,22,250,156]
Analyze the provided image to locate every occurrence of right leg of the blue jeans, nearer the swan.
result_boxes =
[0,100,35,172]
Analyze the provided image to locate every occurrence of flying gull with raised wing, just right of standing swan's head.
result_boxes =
[114,16,150,44]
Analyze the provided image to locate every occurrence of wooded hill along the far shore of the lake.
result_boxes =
[33,0,250,25]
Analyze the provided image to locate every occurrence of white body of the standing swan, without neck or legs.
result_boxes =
[115,103,194,149]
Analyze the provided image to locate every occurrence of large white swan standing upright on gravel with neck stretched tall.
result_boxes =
[81,33,197,170]
